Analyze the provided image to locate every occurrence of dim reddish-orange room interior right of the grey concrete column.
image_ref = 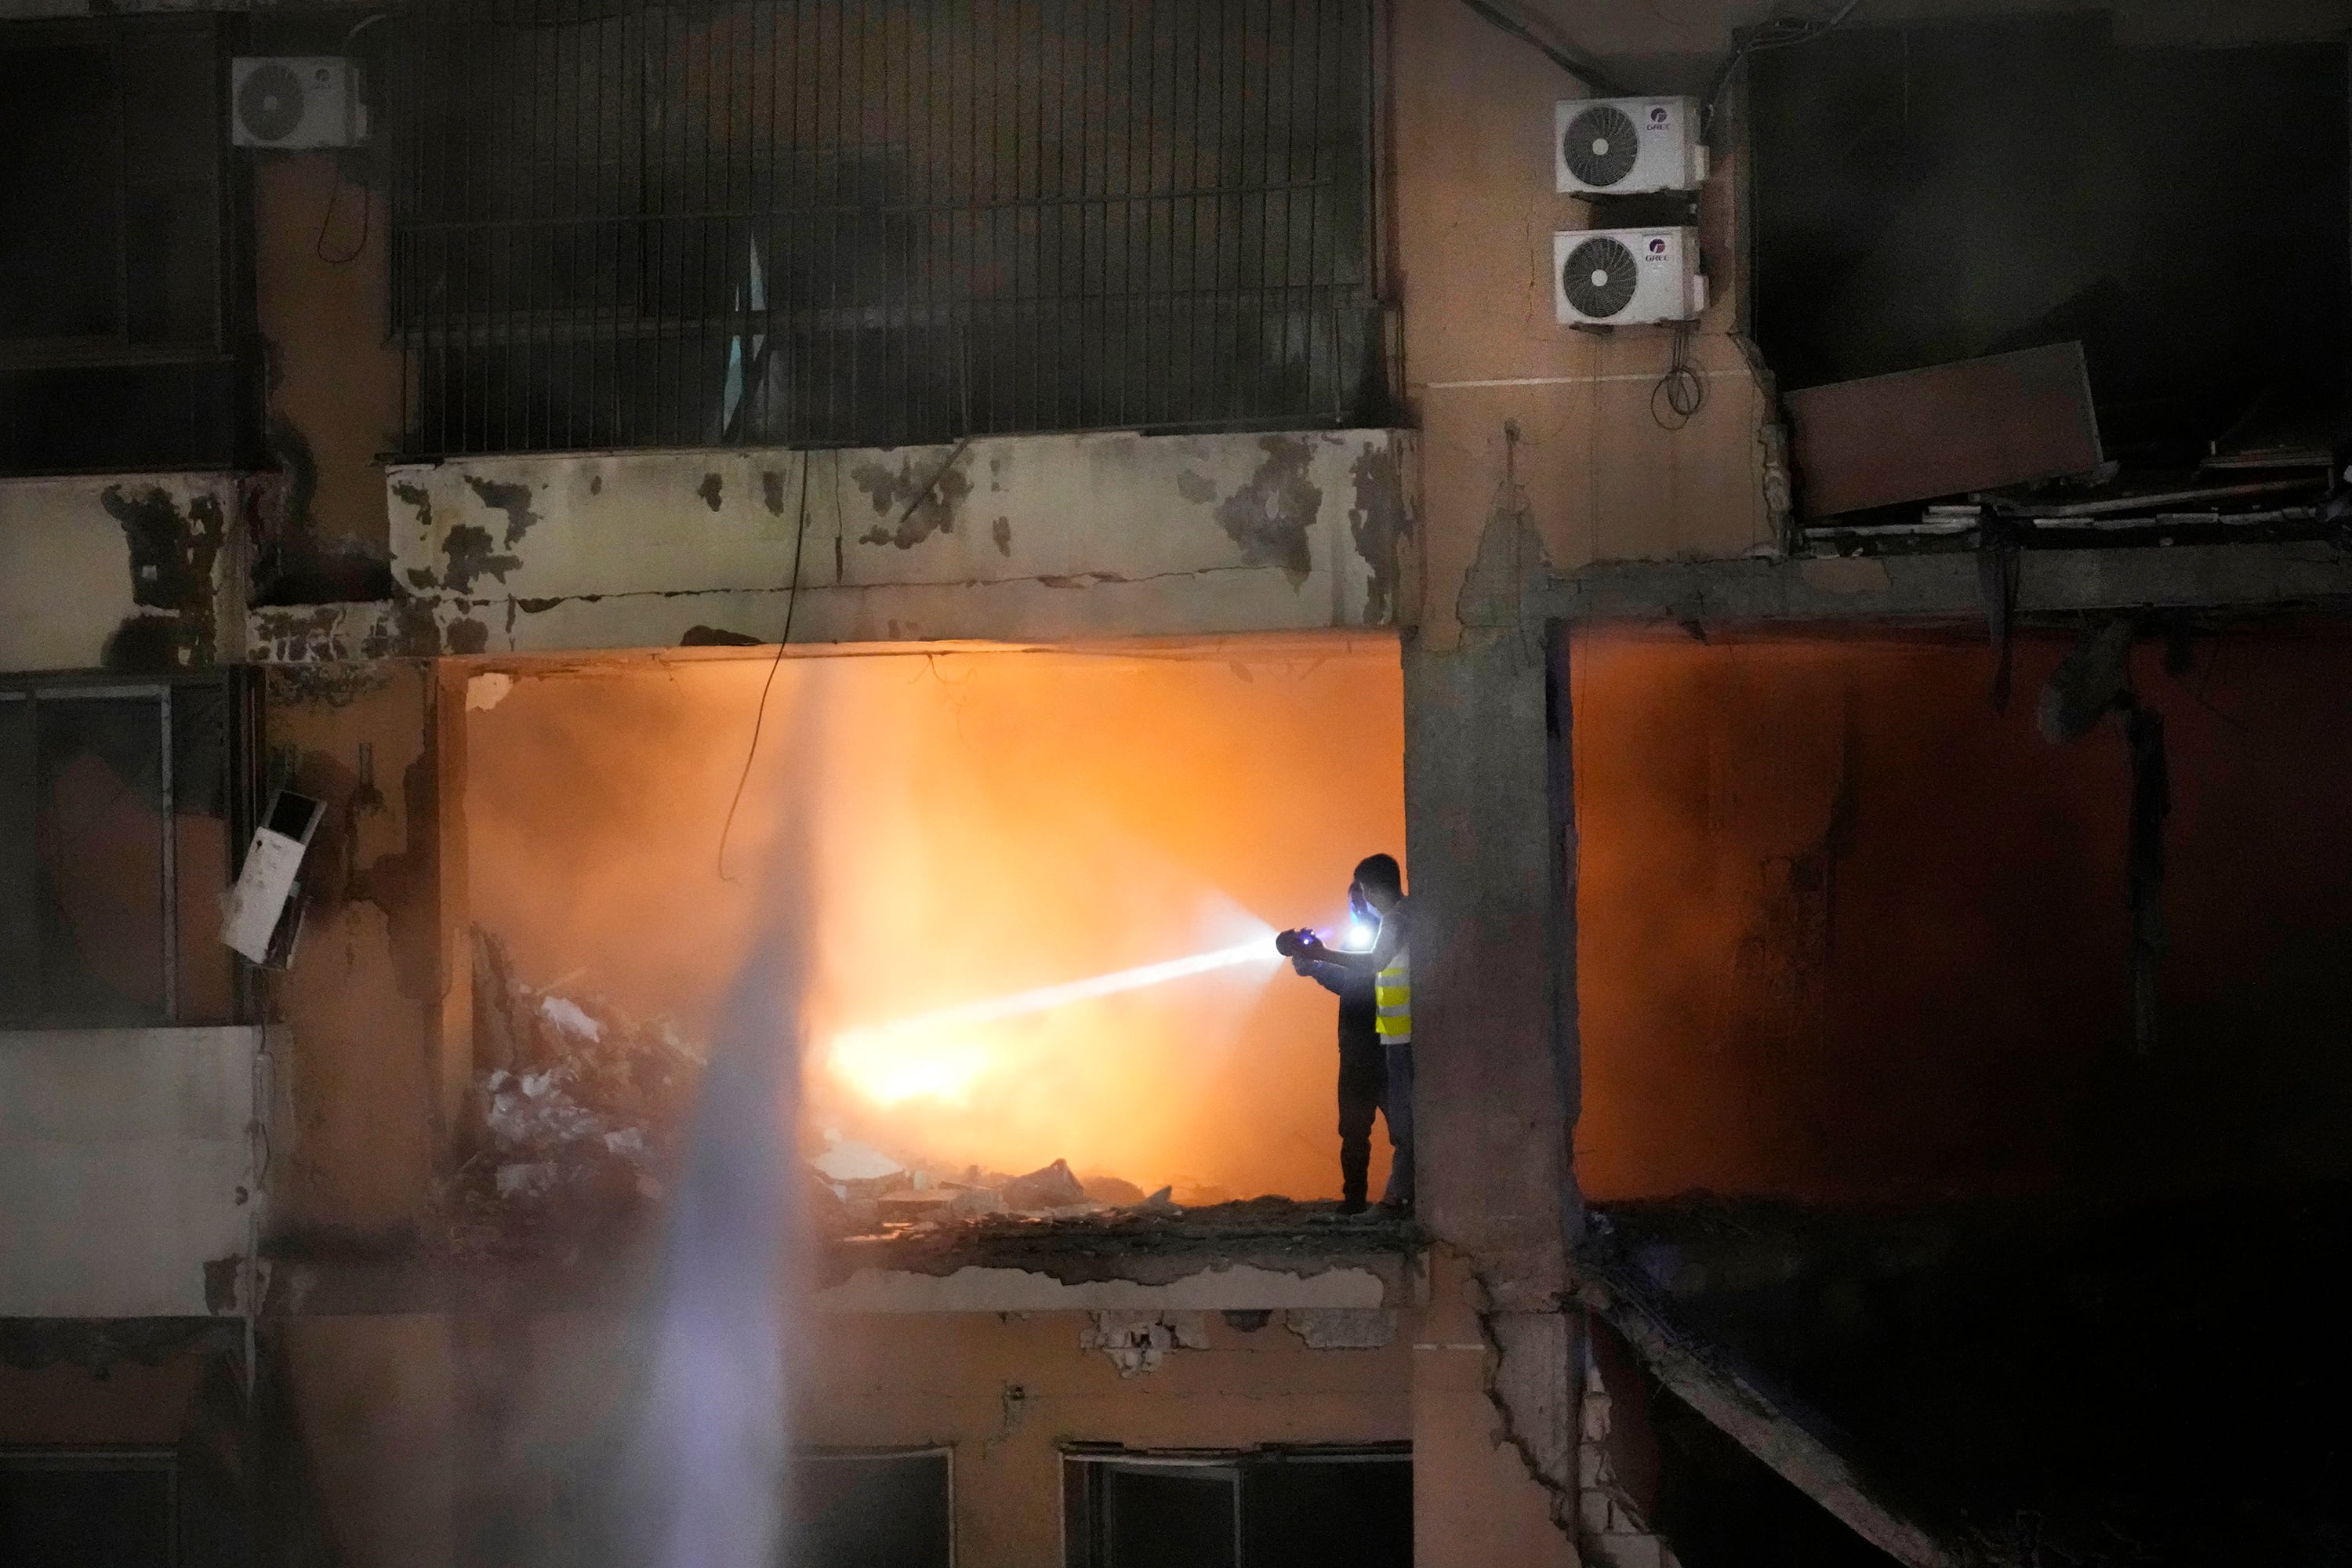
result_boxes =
[1571,630,2352,1203]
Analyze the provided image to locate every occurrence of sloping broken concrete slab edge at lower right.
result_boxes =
[1581,1281,1959,1568]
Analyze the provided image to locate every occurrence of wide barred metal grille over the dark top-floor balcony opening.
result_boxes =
[390,0,1390,456]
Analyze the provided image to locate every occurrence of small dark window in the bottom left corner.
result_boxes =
[0,1450,179,1568]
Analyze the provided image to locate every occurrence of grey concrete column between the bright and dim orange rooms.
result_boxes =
[1404,489,1581,1568]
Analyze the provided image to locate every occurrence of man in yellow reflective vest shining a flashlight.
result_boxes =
[1275,855,1414,1215]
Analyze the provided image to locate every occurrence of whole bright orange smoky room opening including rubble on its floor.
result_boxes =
[466,637,1404,1229]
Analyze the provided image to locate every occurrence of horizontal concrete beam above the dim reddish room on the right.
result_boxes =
[1526,541,2352,623]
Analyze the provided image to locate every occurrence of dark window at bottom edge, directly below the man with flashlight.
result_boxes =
[1061,1448,1414,1568]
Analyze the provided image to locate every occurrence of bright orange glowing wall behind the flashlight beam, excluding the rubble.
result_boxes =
[466,640,1404,1199]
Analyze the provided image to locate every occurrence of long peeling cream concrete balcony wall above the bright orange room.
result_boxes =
[267,430,1414,661]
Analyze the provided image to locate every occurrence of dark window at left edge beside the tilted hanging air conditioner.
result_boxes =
[0,682,249,1027]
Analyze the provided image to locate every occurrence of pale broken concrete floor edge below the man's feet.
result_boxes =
[816,1262,1399,1312]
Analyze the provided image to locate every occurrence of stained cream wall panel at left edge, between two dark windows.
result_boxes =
[0,475,245,675]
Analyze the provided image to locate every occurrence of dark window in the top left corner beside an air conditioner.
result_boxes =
[0,14,249,473]
